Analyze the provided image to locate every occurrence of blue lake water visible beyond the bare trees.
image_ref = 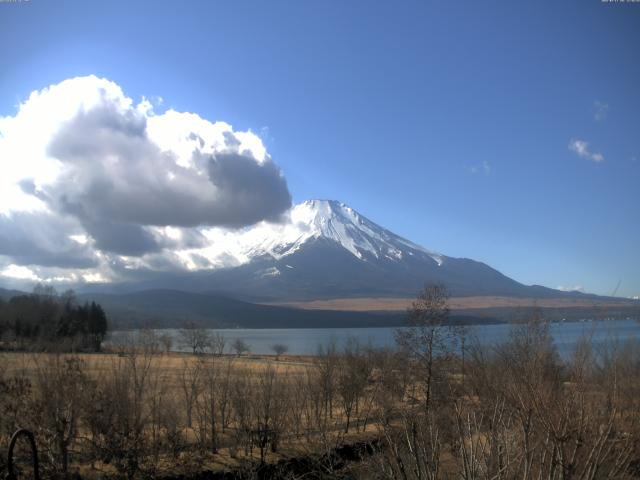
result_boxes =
[110,319,640,358]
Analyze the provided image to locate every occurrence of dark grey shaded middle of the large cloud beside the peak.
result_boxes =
[42,102,291,255]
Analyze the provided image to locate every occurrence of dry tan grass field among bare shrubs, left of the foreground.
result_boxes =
[0,350,377,479]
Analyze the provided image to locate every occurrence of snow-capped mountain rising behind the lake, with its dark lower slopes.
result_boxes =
[116,200,583,301]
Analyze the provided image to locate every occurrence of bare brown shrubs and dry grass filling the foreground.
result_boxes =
[0,289,640,480]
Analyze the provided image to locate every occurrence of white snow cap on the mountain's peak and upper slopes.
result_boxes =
[188,200,445,270]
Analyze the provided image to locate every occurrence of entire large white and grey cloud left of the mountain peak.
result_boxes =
[0,76,291,279]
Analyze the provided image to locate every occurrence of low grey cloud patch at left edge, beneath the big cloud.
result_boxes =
[0,212,97,268]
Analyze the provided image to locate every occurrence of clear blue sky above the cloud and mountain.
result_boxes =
[0,0,640,296]
